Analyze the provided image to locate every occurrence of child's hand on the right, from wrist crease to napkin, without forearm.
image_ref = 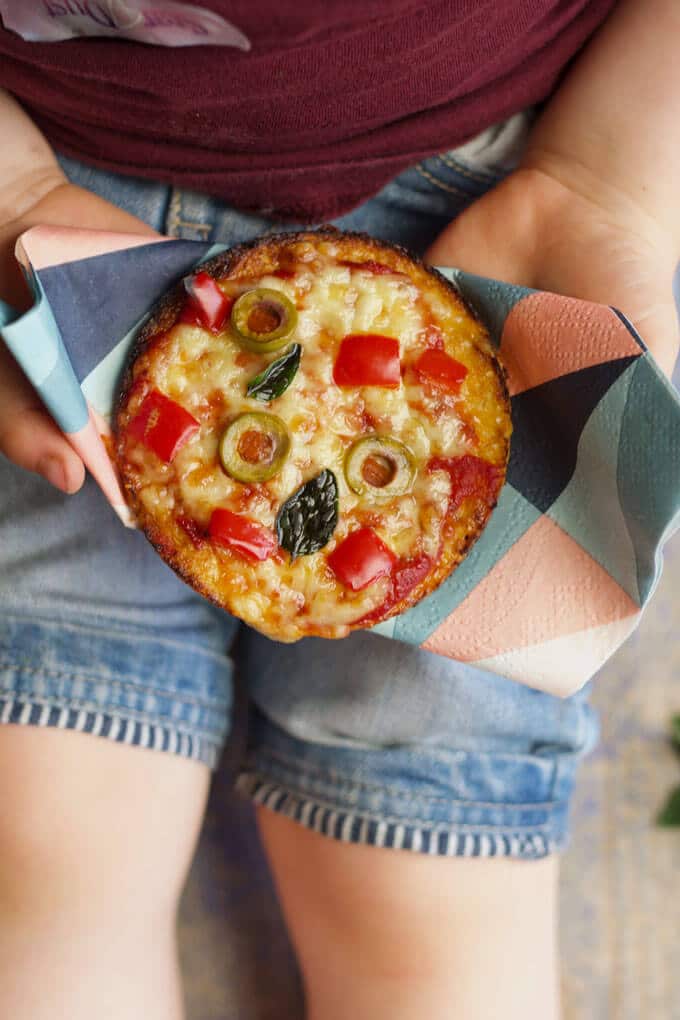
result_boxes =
[426,167,678,374]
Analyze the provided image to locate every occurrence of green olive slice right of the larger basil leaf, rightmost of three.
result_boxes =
[345,436,416,503]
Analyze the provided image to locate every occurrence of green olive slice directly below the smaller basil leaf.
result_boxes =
[219,411,291,482]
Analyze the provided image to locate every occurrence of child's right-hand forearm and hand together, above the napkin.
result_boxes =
[428,0,680,383]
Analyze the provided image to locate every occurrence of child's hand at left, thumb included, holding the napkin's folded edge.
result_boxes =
[0,177,155,493]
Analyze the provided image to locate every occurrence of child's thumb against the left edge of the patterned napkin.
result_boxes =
[0,341,85,493]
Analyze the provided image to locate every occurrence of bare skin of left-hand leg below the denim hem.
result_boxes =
[0,726,209,1020]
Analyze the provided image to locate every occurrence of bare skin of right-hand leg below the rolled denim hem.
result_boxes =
[259,808,559,1020]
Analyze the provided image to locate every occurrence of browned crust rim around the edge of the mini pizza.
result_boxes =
[114,234,511,641]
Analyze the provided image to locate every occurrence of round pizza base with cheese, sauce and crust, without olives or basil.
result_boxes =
[115,228,511,642]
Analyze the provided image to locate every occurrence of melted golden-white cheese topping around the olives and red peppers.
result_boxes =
[118,241,509,640]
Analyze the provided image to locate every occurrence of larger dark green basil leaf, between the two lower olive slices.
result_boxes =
[276,468,337,560]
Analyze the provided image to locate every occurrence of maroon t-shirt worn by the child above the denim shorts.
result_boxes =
[0,0,615,220]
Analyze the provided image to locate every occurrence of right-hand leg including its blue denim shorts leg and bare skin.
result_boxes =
[239,633,596,1020]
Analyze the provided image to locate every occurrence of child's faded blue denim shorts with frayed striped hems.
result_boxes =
[0,113,596,858]
